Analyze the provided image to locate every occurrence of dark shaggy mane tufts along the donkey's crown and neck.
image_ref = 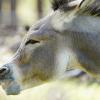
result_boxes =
[52,0,100,17]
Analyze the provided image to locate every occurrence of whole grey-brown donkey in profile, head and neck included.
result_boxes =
[0,0,100,95]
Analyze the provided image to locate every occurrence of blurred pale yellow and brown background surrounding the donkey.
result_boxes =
[0,0,100,100]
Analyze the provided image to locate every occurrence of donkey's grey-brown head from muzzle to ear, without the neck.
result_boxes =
[0,0,99,95]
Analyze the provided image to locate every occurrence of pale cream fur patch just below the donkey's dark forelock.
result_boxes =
[51,10,76,32]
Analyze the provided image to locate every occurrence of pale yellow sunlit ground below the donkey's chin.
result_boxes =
[0,81,100,100]
